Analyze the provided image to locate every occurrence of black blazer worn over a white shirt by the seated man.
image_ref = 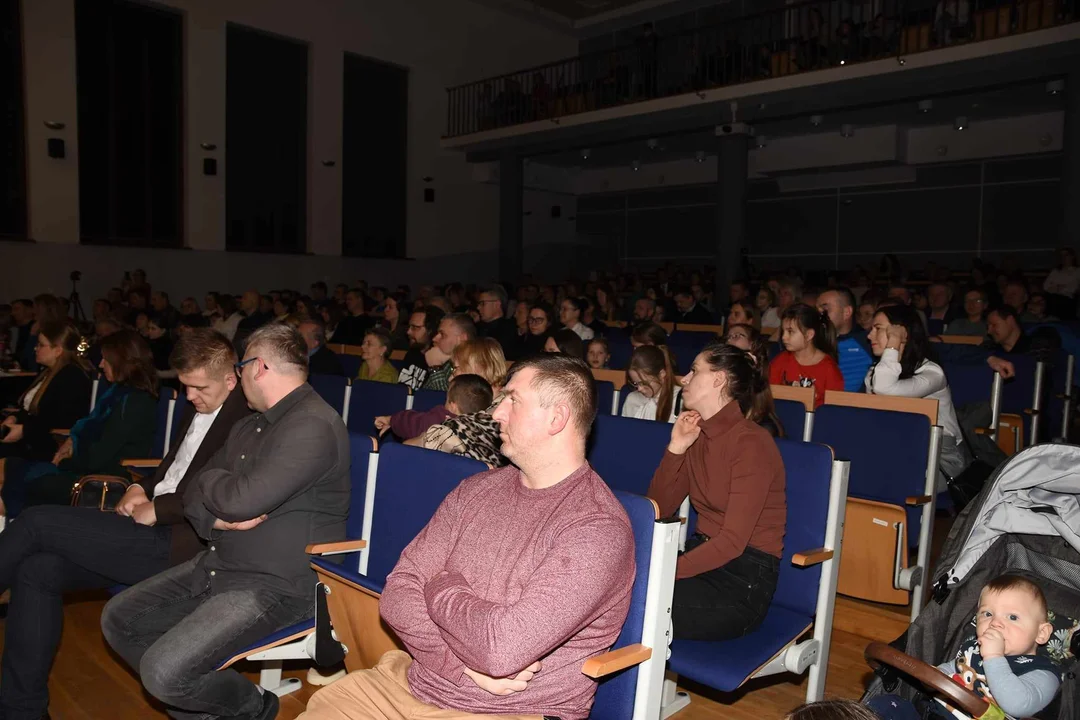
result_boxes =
[138,383,252,565]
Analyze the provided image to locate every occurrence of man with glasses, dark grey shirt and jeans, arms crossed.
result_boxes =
[102,323,350,720]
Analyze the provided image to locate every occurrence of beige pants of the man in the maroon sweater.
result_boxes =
[300,650,542,720]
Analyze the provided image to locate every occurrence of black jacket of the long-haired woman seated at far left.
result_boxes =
[15,364,93,461]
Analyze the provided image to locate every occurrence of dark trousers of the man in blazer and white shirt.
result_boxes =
[0,505,172,720]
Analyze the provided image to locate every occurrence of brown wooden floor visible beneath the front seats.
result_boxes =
[0,596,869,720]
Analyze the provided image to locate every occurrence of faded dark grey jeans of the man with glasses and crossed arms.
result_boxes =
[102,556,314,719]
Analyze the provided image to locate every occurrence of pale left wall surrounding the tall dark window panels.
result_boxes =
[0,0,577,296]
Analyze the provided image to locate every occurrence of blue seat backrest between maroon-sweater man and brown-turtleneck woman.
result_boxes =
[588,415,672,495]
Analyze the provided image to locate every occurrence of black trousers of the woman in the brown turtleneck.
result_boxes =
[672,534,780,640]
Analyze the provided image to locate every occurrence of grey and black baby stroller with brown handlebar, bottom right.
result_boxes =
[863,444,1080,720]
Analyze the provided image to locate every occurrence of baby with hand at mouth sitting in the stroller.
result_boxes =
[869,574,1061,720]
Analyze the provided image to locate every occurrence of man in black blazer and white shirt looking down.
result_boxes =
[0,328,251,718]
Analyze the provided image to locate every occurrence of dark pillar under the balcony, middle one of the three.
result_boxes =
[713,123,750,310]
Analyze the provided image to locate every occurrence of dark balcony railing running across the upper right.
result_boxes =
[446,0,1080,137]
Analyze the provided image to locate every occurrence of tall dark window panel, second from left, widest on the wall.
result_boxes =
[76,0,184,246]
